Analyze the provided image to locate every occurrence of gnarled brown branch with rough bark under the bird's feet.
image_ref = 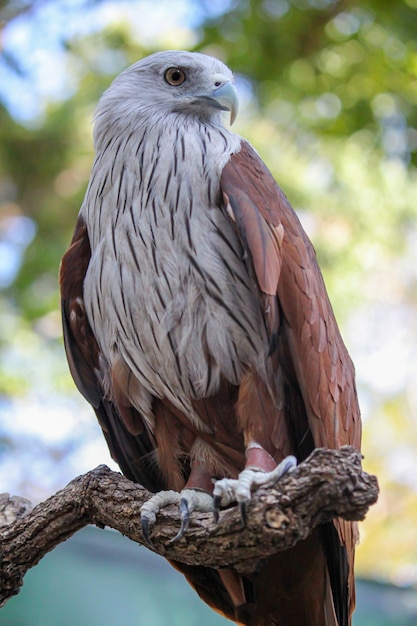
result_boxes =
[0,446,378,605]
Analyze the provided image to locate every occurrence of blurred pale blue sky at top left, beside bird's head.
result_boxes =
[0,0,208,123]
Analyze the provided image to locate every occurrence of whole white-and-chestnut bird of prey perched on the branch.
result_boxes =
[60,50,361,626]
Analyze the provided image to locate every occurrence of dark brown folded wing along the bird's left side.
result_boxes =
[60,217,164,491]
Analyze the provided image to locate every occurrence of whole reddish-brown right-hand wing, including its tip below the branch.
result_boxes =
[221,141,361,624]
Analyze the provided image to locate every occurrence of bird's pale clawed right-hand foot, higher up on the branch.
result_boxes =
[213,441,297,526]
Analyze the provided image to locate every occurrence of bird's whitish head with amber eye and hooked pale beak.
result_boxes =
[98,51,238,128]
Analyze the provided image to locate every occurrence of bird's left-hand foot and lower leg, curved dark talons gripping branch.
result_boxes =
[140,460,213,548]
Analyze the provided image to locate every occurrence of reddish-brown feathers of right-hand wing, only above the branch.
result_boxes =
[221,142,360,448]
